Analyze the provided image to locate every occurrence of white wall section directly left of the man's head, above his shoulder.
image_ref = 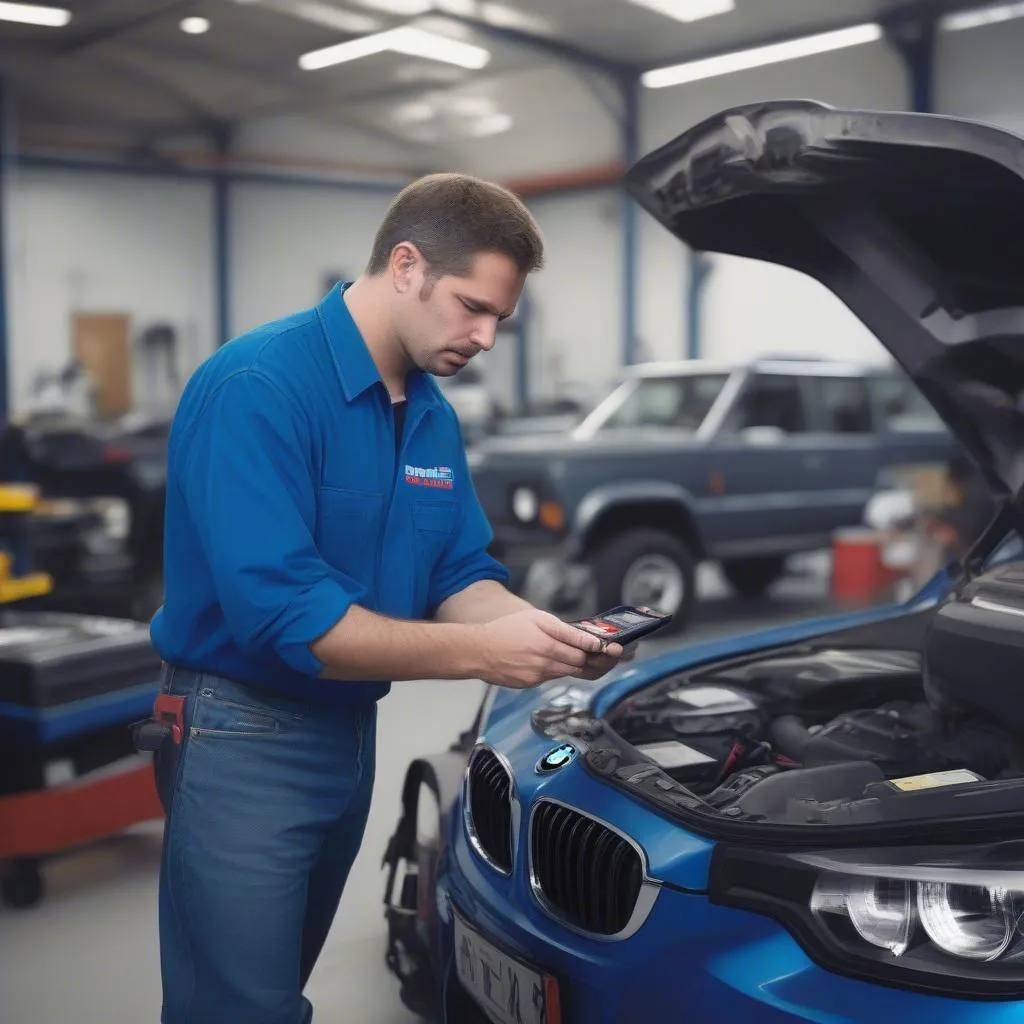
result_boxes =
[230,183,393,334]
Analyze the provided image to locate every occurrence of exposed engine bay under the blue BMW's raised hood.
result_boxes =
[531,562,1024,842]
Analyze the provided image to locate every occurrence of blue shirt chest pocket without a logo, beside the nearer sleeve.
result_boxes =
[315,486,384,587]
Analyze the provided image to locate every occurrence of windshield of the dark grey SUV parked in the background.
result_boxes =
[580,374,728,435]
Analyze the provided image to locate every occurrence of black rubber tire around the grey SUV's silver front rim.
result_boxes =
[589,529,696,637]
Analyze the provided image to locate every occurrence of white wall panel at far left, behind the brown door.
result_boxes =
[7,169,215,414]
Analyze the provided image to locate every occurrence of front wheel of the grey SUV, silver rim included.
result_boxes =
[590,529,696,636]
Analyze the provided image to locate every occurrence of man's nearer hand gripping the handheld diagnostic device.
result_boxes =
[476,608,623,689]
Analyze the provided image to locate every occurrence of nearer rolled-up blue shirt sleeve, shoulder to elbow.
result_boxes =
[177,370,366,676]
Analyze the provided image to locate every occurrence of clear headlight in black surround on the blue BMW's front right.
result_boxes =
[711,841,1024,999]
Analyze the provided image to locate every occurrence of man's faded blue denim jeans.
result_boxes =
[151,669,377,1024]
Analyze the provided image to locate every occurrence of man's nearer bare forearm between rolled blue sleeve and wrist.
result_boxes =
[310,605,484,681]
